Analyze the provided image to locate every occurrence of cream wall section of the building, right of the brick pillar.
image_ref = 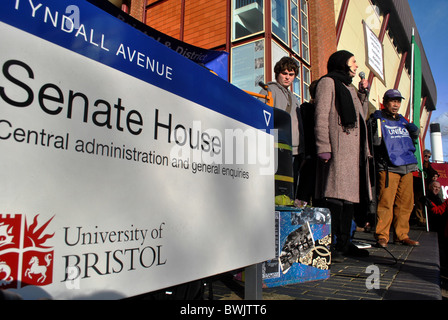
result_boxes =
[334,0,437,142]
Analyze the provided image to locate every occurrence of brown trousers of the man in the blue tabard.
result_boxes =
[375,171,414,241]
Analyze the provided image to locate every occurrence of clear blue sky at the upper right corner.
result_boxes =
[408,0,448,162]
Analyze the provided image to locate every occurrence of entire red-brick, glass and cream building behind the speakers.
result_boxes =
[117,0,437,145]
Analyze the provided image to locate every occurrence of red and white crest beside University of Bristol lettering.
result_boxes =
[0,214,54,289]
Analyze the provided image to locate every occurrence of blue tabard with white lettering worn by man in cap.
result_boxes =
[379,115,417,166]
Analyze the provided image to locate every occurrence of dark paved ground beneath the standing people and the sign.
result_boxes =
[208,228,448,300]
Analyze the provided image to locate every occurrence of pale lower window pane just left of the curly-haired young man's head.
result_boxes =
[231,40,264,92]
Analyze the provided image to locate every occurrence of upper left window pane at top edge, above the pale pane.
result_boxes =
[232,0,264,40]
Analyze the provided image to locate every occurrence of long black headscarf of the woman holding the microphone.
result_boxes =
[324,50,357,129]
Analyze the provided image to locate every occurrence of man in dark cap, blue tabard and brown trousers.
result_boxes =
[369,89,420,247]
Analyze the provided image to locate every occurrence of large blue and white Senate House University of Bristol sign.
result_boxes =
[0,0,275,299]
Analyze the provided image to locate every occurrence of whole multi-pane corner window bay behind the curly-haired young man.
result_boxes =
[231,0,311,103]
